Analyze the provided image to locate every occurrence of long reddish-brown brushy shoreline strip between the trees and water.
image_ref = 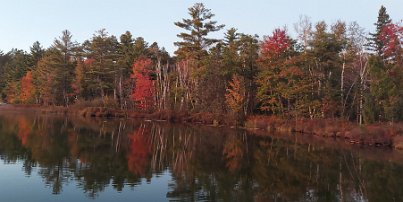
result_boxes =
[0,104,403,150]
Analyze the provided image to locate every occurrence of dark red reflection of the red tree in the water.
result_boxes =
[127,127,151,175]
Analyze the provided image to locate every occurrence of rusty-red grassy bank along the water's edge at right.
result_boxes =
[245,116,403,149]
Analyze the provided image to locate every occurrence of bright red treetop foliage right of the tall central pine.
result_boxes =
[261,29,291,59]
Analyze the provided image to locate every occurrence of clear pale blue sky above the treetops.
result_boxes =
[0,0,403,53]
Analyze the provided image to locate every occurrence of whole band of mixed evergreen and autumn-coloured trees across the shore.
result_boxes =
[0,3,403,123]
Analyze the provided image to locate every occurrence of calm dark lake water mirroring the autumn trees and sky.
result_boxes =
[0,111,403,202]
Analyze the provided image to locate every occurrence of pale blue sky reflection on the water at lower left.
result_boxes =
[0,161,172,202]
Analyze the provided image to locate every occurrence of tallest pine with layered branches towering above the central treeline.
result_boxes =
[174,3,225,110]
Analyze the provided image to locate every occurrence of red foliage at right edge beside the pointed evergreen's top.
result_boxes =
[379,23,403,58]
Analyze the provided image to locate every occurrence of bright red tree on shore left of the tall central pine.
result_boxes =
[131,58,154,110]
